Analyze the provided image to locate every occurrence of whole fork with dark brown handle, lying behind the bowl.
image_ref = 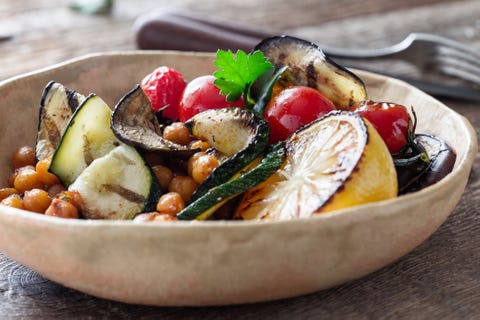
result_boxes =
[135,12,480,101]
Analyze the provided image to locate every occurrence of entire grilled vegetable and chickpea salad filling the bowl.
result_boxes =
[0,36,455,221]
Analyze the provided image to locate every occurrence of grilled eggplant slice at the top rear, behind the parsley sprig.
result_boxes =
[255,36,367,109]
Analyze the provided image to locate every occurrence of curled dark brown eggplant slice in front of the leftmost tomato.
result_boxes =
[111,85,198,155]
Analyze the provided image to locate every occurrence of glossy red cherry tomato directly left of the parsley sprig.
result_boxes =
[178,75,244,122]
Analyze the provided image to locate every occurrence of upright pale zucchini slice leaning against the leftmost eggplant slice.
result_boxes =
[49,94,121,187]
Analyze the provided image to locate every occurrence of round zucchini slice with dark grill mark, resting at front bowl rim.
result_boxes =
[68,143,160,219]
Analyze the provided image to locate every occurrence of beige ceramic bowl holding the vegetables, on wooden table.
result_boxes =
[0,52,477,306]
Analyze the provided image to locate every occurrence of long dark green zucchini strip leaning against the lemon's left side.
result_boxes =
[177,142,285,220]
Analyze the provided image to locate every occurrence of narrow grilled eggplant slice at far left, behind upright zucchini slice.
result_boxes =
[35,81,85,160]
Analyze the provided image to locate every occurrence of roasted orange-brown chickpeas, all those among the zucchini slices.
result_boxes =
[0,122,219,221]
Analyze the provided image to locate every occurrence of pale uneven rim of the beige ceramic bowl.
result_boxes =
[0,50,478,229]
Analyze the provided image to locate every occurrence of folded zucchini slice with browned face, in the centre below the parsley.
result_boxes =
[185,108,270,202]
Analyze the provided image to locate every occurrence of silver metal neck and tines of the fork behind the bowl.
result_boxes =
[324,33,480,100]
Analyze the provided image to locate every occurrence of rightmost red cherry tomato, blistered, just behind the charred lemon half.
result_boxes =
[352,100,412,153]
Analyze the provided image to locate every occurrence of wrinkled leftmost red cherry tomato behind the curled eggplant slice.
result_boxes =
[140,66,187,120]
